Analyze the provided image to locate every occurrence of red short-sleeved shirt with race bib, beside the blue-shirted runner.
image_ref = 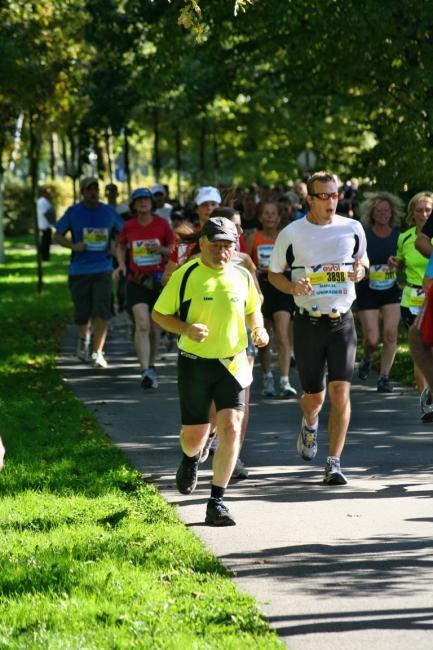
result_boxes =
[119,215,173,279]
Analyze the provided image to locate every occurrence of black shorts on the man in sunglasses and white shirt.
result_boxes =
[293,311,356,393]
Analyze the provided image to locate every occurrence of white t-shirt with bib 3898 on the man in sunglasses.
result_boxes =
[269,214,367,314]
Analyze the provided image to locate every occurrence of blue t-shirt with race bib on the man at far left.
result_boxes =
[55,202,123,275]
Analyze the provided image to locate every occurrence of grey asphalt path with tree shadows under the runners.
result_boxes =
[58,312,433,650]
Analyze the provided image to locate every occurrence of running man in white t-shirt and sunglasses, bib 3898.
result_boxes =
[269,172,368,485]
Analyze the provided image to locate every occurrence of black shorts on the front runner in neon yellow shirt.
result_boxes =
[177,354,245,424]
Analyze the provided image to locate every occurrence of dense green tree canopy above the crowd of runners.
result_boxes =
[0,0,433,192]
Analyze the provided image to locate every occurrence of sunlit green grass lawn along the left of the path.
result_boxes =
[0,240,284,650]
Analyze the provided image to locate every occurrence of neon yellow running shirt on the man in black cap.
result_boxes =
[155,259,260,359]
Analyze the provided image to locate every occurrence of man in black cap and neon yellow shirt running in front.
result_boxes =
[152,217,269,526]
